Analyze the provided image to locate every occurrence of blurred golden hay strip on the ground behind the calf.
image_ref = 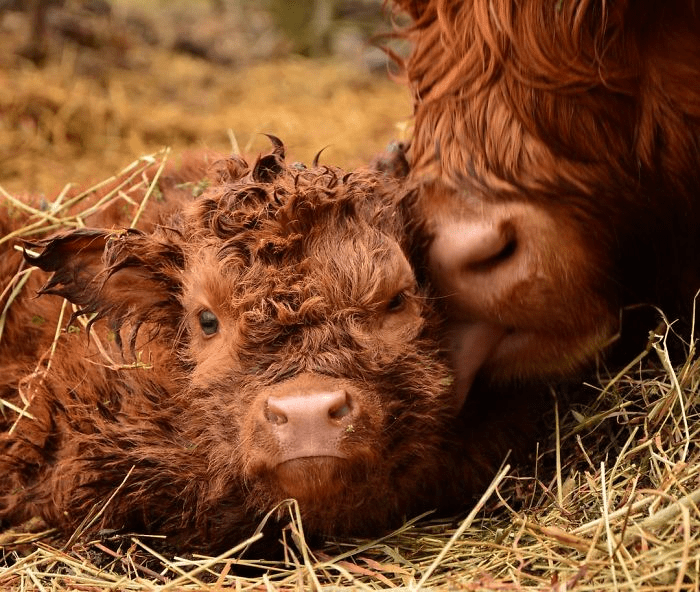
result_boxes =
[0,0,412,195]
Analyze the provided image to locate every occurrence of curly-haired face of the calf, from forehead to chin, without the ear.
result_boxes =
[182,172,456,532]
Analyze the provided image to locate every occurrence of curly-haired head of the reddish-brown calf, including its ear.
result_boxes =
[29,143,461,533]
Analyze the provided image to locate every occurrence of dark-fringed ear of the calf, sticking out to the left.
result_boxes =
[24,228,184,349]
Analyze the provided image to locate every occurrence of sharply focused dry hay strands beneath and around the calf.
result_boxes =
[0,154,700,592]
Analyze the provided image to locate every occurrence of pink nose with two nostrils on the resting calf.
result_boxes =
[265,390,357,462]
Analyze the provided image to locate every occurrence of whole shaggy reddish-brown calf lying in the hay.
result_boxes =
[0,143,527,549]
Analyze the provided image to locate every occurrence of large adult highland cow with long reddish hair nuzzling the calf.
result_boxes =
[396,0,700,402]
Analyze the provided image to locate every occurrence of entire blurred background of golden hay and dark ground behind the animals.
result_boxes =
[0,0,411,196]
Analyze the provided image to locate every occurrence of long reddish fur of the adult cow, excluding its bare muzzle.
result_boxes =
[395,0,700,346]
